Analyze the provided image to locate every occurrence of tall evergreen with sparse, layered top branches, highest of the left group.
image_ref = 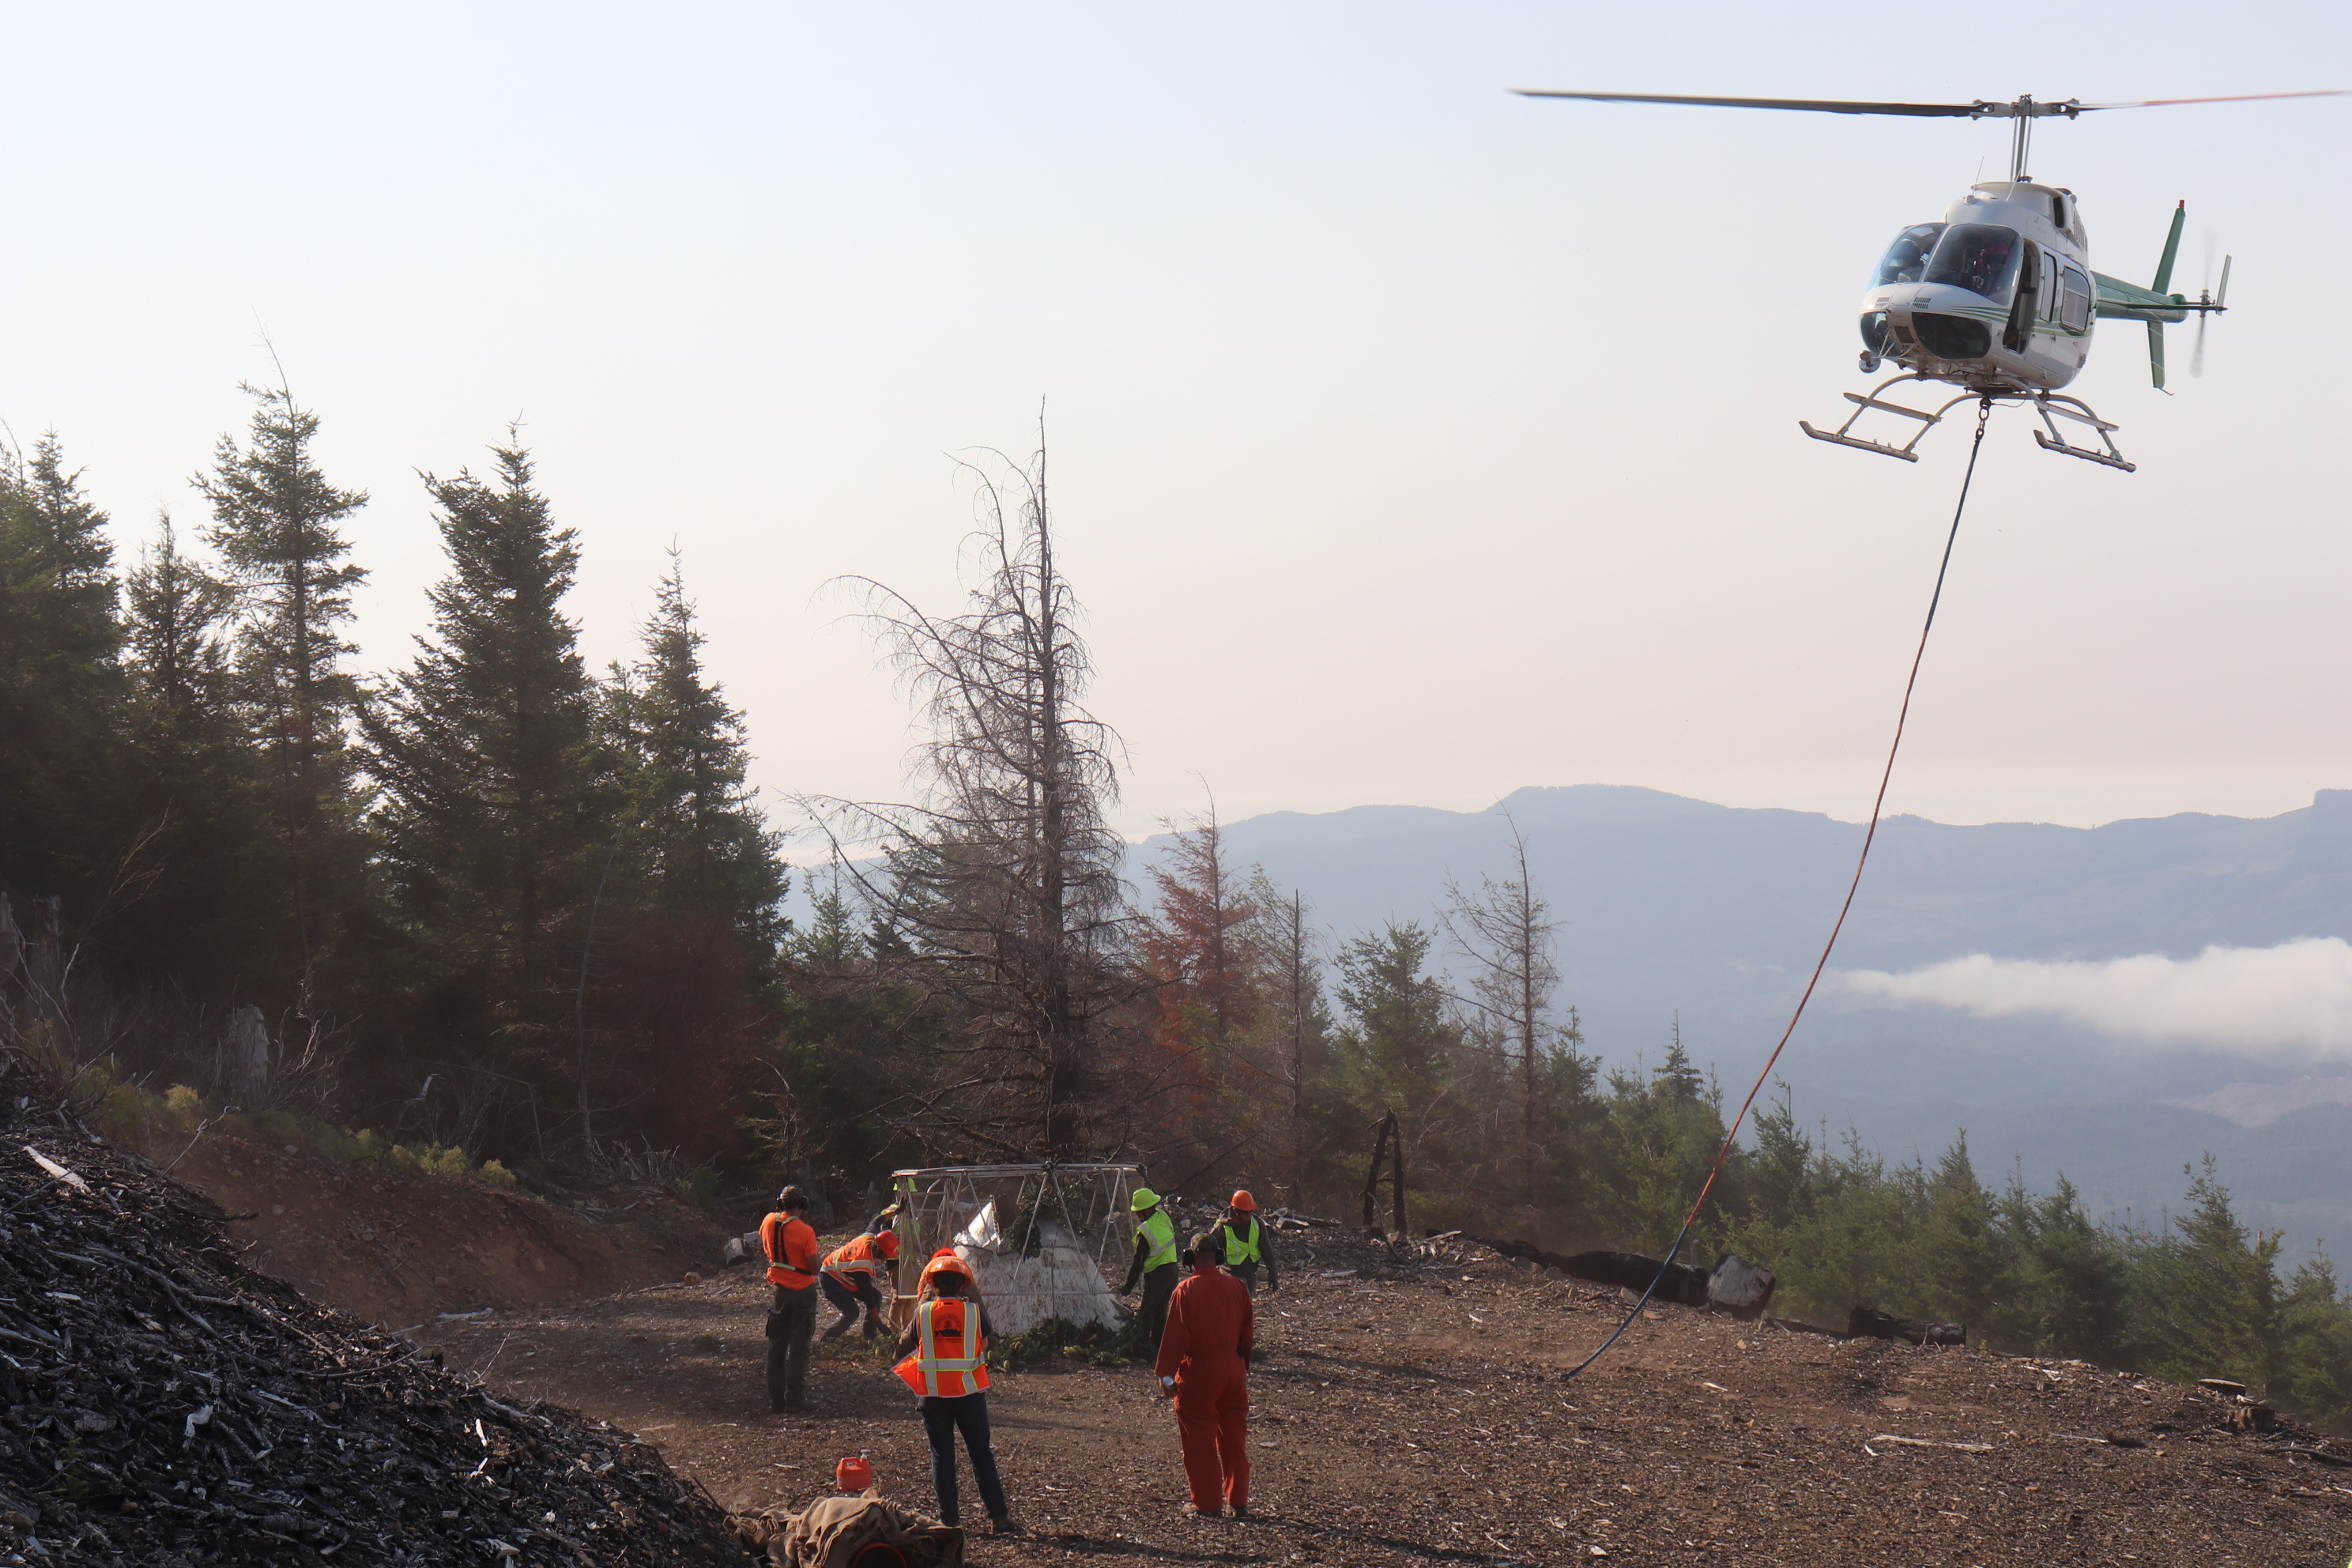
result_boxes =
[195,386,367,1001]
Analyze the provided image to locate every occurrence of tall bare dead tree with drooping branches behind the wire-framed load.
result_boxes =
[802,435,1138,1159]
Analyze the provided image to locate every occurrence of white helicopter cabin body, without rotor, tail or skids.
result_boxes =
[1860,181,2098,393]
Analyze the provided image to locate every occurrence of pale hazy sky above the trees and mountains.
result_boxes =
[0,0,2352,832]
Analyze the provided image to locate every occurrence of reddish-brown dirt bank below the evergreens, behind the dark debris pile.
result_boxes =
[162,1138,725,1329]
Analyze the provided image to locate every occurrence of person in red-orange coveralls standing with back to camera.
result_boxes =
[1157,1237,1258,1519]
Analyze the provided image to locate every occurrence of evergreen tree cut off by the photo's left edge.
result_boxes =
[0,432,125,924]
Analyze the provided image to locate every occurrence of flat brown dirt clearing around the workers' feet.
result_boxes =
[409,1257,2352,1568]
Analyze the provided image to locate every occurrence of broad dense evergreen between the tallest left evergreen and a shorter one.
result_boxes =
[364,444,616,1142]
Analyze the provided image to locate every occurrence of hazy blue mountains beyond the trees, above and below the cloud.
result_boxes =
[1138,785,2352,1246]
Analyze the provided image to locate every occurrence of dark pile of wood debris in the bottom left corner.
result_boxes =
[0,1110,745,1568]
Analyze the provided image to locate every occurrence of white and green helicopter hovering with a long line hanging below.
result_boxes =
[1513,87,2343,473]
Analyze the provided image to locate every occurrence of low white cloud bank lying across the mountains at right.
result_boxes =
[1837,936,2352,1061]
